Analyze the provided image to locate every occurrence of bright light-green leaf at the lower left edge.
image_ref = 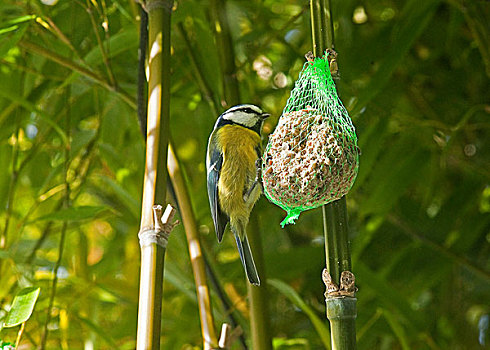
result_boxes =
[3,287,41,328]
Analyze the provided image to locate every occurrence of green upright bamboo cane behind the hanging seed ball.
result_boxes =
[310,0,357,350]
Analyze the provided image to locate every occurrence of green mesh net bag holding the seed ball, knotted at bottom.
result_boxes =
[262,54,359,227]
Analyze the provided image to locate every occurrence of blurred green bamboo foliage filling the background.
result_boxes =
[0,0,490,349]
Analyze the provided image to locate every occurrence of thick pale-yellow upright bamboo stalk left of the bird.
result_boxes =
[136,0,173,350]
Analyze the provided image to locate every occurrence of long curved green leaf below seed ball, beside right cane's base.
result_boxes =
[267,279,330,349]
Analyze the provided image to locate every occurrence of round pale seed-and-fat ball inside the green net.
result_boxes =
[262,108,358,208]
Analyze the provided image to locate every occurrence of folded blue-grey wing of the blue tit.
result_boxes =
[207,141,230,242]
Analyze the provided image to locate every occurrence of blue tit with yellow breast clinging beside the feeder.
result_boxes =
[206,104,269,285]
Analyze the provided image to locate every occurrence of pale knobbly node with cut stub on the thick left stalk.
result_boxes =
[138,204,179,248]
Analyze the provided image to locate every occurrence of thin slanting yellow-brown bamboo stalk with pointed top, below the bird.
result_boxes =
[167,145,218,350]
